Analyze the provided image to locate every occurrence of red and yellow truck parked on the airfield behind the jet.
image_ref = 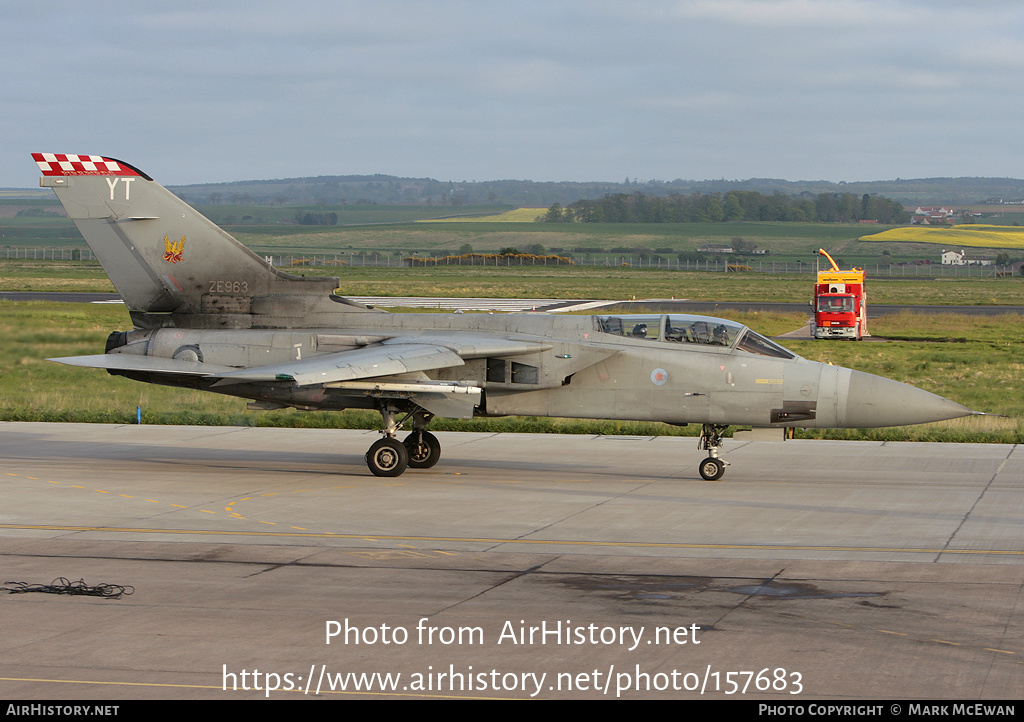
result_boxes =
[811,249,870,341]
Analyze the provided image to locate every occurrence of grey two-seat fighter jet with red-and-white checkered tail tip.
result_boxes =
[33,153,975,480]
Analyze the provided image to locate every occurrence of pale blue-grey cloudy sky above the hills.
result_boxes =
[0,0,1024,187]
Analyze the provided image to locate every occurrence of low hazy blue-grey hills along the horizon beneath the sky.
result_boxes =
[170,175,1024,208]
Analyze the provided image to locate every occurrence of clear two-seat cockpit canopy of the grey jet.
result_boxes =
[594,313,797,358]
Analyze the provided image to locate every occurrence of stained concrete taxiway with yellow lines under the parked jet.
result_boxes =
[0,423,1024,704]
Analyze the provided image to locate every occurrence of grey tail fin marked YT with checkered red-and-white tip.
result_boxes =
[33,153,356,328]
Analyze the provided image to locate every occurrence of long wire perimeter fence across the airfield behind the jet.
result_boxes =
[0,246,1021,279]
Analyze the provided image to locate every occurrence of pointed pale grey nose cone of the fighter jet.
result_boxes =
[845,371,976,428]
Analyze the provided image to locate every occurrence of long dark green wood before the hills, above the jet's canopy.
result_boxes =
[540,190,907,224]
